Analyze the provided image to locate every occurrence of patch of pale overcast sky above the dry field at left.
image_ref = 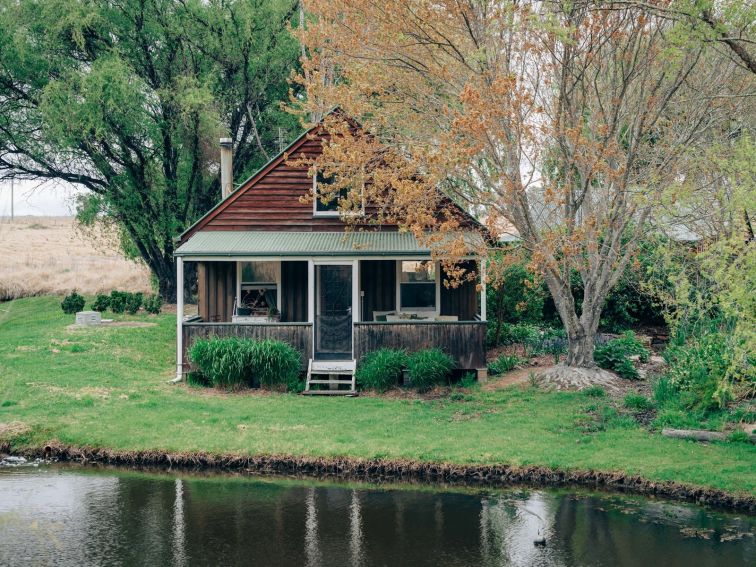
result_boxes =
[0,181,84,217]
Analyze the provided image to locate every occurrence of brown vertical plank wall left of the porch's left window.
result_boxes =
[197,262,236,323]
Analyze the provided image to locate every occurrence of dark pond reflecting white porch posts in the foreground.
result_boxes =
[0,464,756,567]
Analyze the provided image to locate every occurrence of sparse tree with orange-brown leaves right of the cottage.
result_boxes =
[300,0,747,383]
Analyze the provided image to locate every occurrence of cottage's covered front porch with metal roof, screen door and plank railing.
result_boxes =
[176,232,486,377]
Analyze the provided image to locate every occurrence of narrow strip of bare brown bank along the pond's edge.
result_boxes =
[0,441,756,514]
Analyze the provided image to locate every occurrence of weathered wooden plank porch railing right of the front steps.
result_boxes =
[354,321,486,369]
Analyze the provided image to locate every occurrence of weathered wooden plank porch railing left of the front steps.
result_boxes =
[182,322,312,370]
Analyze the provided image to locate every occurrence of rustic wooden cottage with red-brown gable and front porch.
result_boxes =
[175,117,486,393]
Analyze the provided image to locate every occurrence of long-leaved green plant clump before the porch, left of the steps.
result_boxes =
[189,337,301,389]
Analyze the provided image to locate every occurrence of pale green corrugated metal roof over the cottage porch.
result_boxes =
[175,231,480,256]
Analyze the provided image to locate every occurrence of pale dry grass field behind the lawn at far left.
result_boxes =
[0,217,150,301]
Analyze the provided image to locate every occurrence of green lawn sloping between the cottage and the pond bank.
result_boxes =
[0,297,756,494]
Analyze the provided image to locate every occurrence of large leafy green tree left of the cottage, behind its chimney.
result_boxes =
[0,0,299,301]
